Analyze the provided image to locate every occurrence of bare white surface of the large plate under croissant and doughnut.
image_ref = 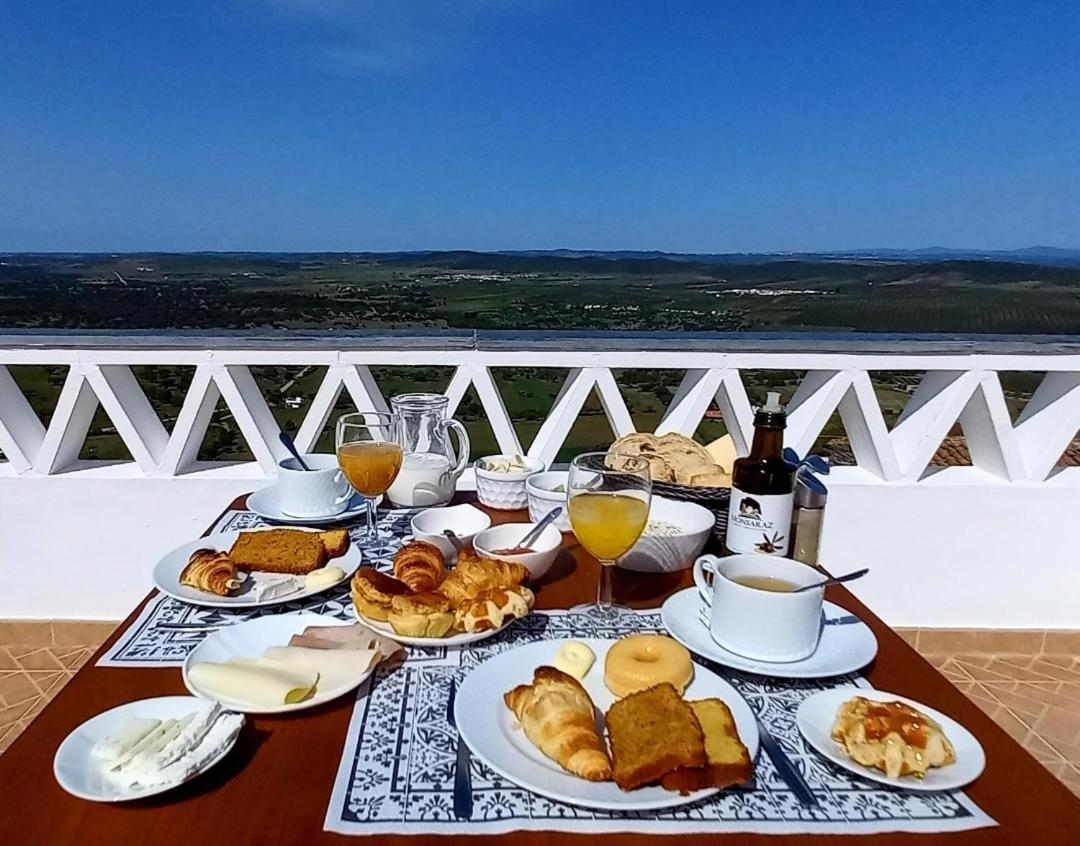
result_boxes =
[454,639,758,810]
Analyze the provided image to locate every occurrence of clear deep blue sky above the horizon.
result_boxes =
[0,0,1080,252]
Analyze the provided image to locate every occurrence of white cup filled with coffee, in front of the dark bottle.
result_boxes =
[693,554,825,663]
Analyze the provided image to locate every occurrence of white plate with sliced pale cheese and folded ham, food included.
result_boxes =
[183,612,402,714]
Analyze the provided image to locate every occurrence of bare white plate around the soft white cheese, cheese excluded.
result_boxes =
[53,696,240,802]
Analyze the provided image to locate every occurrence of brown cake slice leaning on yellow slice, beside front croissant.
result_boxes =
[606,682,706,790]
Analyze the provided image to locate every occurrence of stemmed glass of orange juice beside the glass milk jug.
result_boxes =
[335,412,403,540]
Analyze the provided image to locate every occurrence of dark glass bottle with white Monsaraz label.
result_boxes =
[725,392,795,555]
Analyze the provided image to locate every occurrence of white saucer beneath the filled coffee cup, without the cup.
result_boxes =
[660,588,877,679]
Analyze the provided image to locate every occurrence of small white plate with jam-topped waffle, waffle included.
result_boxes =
[795,687,986,792]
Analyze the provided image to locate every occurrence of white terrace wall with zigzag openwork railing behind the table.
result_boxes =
[0,333,1080,629]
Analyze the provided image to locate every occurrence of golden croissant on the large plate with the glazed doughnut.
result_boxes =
[502,667,611,781]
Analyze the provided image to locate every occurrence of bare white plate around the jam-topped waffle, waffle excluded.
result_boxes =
[795,687,986,793]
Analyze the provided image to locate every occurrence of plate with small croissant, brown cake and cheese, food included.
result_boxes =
[153,526,362,608]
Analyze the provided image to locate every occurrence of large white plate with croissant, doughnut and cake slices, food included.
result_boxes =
[455,634,758,810]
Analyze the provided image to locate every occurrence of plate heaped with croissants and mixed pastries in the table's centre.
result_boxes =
[350,540,534,646]
